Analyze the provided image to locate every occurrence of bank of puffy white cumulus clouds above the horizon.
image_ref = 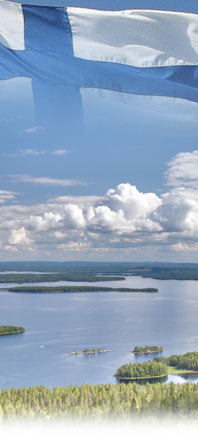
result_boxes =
[0,151,198,261]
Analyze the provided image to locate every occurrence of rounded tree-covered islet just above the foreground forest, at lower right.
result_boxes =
[115,361,168,380]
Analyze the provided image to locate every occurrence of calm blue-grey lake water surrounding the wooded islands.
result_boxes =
[0,277,198,388]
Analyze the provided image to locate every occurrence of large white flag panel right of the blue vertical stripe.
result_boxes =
[68,8,198,68]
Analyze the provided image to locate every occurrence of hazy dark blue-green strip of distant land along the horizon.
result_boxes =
[0,261,198,284]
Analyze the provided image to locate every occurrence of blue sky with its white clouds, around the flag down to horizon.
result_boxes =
[0,0,198,262]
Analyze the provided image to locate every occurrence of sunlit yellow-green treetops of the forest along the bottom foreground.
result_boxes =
[0,383,198,421]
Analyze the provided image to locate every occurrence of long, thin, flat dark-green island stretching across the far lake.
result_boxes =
[5,286,158,293]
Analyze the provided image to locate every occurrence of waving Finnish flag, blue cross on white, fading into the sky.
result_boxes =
[0,1,198,129]
